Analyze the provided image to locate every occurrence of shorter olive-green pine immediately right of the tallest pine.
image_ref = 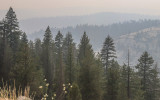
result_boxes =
[11,33,30,89]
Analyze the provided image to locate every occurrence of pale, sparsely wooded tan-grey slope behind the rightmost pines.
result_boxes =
[115,27,160,65]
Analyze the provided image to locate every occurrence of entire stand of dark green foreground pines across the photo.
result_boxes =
[0,8,160,100]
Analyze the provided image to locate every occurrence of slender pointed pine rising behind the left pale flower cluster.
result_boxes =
[42,26,54,98]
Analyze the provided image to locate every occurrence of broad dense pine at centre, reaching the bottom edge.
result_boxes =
[78,32,102,100]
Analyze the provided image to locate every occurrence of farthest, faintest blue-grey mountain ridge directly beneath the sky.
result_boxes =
[20,12,159,34]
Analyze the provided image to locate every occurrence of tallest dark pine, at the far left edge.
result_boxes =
[0,7,21,81]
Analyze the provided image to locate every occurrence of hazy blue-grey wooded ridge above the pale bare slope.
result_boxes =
[28,20,160,51]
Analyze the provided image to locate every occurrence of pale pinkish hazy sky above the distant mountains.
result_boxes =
[0,0,160,19]
